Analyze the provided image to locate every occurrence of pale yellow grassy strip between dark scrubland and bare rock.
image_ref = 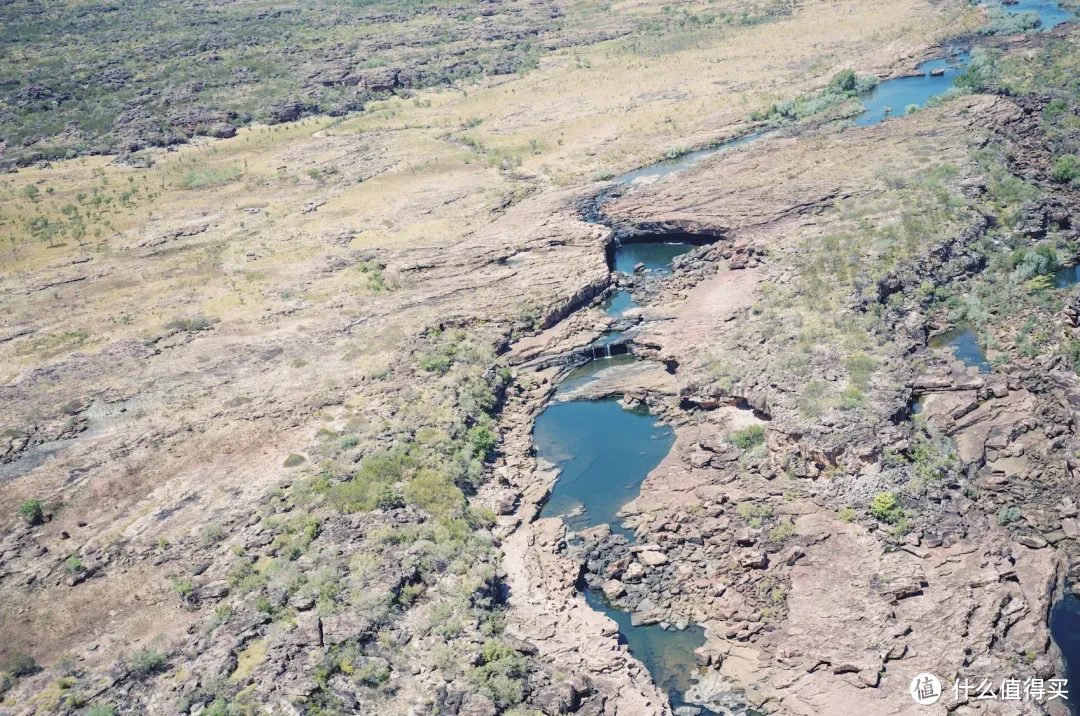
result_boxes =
[0,0,977,365]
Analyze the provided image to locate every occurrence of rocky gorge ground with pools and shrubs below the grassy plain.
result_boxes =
[6,1,1080,716]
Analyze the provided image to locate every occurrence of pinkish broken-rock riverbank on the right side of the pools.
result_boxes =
[496,53,1080,714]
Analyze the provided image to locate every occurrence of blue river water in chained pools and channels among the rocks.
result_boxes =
[534,9,1080,716]
